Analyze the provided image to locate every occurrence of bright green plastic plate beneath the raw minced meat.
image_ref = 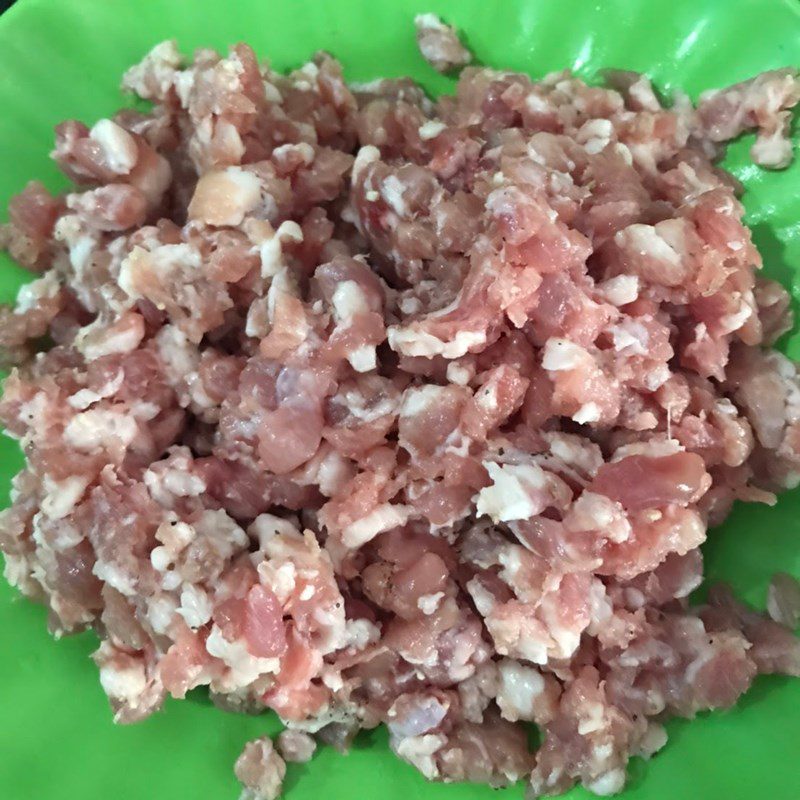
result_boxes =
[0,0,800,800]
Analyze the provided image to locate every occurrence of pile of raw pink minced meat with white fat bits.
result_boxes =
[0,15,800,800]
